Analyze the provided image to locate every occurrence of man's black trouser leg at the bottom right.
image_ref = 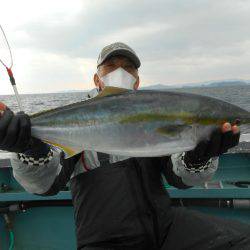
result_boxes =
[83,208,250,250]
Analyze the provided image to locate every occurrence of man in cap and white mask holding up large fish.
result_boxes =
[0,43,250,250]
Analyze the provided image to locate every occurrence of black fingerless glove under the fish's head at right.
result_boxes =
[184,128,240,166]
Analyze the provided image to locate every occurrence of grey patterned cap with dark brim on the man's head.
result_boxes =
[97,42,141,68]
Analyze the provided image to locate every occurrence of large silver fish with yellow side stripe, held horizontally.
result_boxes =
[31,87,250,157]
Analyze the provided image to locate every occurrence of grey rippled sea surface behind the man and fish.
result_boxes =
[0,85,250,157]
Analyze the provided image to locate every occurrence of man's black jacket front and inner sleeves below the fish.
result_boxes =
[43,154,188,249]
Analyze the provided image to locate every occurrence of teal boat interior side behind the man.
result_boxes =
[0,153,250,250]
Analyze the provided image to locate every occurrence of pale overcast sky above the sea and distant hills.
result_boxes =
[0,0,250,94]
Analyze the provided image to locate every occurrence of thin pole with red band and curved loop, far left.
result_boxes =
[0,25,23,111]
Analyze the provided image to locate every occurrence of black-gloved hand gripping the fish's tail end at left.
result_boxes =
[0,102,31,153]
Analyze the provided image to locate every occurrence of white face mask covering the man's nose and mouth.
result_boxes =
[99,67,136,89]
